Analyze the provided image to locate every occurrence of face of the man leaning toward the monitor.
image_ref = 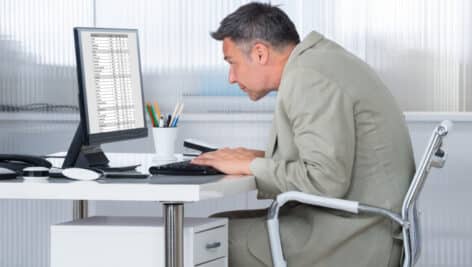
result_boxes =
[223,38,272,101]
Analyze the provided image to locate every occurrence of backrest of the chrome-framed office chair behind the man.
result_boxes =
[401,121,452,267]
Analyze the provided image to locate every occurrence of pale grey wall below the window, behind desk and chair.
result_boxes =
[0,113,472,267]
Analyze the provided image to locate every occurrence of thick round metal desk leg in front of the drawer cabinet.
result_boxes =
[164,203,184,267]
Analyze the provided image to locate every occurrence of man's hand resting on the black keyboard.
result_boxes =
[192,148,264,175]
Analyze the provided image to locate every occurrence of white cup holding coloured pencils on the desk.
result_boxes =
[152,127,177,161]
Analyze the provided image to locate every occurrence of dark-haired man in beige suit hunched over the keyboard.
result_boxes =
[193,3,415,267]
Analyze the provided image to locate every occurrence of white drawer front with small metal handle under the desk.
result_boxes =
[193,225,228,266]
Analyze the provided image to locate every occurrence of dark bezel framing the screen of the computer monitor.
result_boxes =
[74,27,148,145]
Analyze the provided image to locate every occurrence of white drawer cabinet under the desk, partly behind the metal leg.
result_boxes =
[51,216,228,267]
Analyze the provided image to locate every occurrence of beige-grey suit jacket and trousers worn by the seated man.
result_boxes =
[247,32,415,267]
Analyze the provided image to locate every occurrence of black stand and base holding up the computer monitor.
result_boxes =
[62,122,139,171]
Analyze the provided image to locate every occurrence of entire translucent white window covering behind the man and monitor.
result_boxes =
[0,0,472,112]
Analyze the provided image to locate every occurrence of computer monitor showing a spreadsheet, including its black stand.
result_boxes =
[62,27,148,169]
